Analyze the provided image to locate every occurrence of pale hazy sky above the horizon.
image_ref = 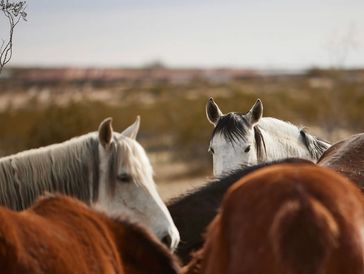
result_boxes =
[0,0,364,69]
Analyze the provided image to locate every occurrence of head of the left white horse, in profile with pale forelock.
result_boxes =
[98,117,180,249]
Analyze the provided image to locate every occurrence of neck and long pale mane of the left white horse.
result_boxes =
[0,134,99,210]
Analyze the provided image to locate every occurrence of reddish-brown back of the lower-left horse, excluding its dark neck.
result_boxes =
[0,198,124,273]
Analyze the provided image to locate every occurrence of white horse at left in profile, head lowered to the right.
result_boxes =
[0,116,179,249]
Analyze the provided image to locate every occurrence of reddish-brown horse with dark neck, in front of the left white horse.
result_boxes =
[0,196,179,274]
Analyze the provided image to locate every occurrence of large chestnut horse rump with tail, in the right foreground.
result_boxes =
[182,164,364,274]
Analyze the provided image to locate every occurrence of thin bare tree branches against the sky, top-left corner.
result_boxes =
[0,0,27,73]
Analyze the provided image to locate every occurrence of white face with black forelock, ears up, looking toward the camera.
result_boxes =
[206,98,263,176]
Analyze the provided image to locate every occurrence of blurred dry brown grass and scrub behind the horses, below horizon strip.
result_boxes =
[0,68,364,199]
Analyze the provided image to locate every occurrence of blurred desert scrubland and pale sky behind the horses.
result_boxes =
[0,0,364,199]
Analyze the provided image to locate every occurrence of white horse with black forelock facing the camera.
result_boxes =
[206,98,330,176]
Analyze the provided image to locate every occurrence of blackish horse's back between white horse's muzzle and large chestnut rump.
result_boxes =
[167,158,313,264]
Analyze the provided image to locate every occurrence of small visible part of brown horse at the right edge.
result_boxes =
[317,133,364,191]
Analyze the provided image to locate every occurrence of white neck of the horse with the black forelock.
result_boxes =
[258,117,311,161]
